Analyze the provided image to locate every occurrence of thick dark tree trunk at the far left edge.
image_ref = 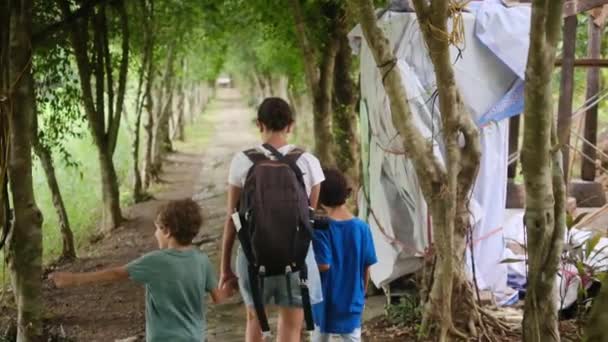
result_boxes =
[0,0,44,342]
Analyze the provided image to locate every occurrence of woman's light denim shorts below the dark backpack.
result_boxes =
[236,248,302,308]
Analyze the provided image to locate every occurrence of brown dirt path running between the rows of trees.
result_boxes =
[45,90,383,342]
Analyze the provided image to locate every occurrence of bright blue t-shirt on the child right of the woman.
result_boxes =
[313,218,377,334]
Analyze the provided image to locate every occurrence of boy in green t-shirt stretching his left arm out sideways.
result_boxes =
[49,199,236,342]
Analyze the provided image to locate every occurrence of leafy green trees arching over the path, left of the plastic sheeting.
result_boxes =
[0,0,366,341]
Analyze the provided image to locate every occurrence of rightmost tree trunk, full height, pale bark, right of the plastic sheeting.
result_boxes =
[521,0,565,342]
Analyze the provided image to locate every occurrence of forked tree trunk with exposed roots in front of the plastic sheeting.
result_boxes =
[357,0,494,341]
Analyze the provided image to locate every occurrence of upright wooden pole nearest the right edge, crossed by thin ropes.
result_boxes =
[581,18,602,181]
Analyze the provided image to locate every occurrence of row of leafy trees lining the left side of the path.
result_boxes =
[0,0,221,341]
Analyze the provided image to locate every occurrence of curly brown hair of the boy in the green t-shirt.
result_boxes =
[156,198,203,245]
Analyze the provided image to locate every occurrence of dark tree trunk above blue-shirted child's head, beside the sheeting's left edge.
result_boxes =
[332,19,360,189]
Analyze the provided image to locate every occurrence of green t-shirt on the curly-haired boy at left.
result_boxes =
[127,248,217,342]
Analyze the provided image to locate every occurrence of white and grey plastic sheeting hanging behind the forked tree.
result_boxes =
[351,12,518,295]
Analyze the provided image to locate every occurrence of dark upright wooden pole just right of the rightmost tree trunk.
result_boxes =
[557,15,578,180]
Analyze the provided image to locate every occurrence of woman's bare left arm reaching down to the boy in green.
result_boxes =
[219,185,241,288]
